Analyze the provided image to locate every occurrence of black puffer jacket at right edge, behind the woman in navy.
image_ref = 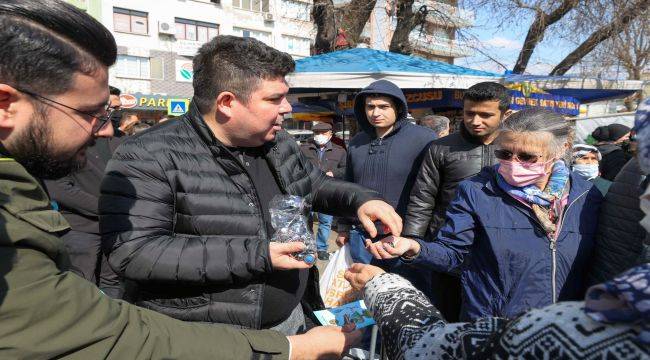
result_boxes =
[587,158,647,284]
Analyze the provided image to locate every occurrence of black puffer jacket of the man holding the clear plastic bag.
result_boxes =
[100,105,379,328]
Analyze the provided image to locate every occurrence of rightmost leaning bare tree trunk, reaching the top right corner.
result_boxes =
[549,0,650,75]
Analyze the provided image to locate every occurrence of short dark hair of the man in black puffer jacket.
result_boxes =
[193,35,296,113]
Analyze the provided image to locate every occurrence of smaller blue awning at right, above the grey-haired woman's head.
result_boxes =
[505,74,644,104]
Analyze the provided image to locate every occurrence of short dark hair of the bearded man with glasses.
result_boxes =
[0,0,117,95]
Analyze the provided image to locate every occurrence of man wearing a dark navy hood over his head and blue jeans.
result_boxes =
[337,80,436,263]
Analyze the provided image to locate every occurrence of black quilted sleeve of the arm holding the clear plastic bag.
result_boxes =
[99,138,272,284]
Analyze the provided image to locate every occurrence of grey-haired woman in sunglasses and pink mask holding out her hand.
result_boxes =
[366,109,602,321]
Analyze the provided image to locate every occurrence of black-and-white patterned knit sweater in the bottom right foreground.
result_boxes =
[365,273,650,360]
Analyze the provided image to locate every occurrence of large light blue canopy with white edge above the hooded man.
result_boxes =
[287,48,502,92]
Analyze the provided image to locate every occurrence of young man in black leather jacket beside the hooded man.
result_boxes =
[403,82,510,321]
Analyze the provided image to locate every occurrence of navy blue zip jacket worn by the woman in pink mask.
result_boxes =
[403,167,603,320]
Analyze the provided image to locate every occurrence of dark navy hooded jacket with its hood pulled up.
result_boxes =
[345,80,437,216]
